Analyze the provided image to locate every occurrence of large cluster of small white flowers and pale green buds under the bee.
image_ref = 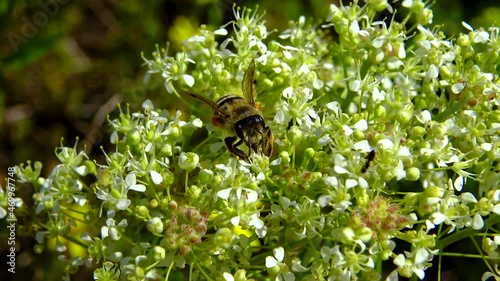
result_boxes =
[6,1,500,280]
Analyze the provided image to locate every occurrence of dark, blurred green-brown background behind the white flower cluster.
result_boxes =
[0,0,500,280]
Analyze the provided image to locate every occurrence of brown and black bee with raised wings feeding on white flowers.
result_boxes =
[180,60,274,161]
